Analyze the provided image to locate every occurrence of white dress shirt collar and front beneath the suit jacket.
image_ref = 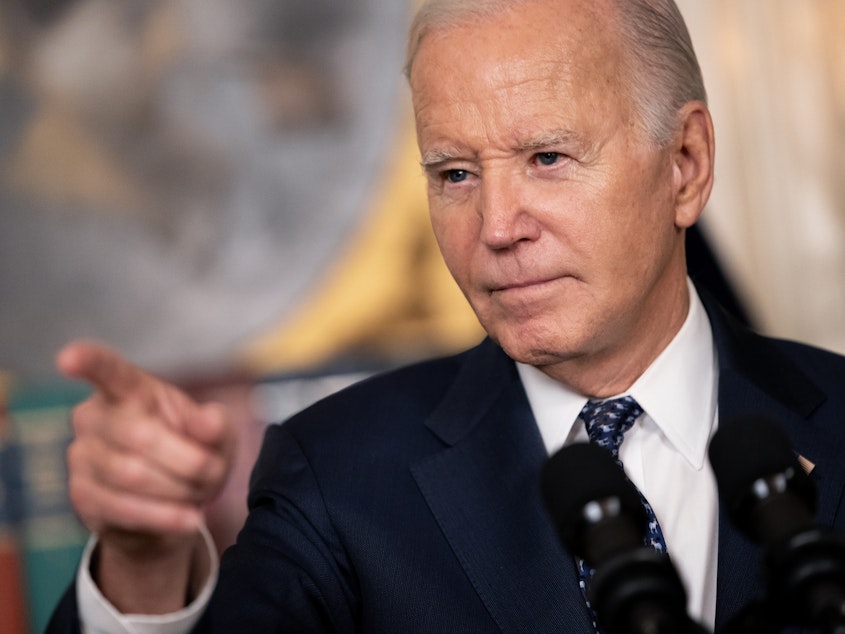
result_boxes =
[517,283,719,631]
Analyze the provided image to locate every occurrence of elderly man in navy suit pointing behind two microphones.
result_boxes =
[52,0,845,632]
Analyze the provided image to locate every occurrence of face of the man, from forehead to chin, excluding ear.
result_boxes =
[411,0,687,390]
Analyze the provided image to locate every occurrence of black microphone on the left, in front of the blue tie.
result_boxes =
[540,443,703,634]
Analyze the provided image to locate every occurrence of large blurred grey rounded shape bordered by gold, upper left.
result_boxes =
[0,0,442,375]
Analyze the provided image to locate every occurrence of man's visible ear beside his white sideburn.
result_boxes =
[672,101,716,229]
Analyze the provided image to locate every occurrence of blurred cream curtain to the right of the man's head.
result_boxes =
[678,0,845,352]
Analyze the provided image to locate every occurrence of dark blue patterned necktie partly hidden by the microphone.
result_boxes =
[576,396,666,632]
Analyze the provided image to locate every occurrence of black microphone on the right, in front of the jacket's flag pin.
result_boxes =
[709,416,845,632]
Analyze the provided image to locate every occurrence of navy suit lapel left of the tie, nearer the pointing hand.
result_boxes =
[412,342,590,632]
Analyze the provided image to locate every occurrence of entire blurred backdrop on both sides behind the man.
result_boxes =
[0,0,845,632]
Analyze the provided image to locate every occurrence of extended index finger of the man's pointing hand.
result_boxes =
[56,341,149,401]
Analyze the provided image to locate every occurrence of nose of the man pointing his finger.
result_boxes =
[479,172,540,250]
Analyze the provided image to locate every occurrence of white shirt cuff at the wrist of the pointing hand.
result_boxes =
[76,526,220,634]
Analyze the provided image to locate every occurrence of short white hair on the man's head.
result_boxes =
[405,0,707,146]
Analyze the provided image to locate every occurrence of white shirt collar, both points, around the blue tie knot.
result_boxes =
[517,280,718,469]
